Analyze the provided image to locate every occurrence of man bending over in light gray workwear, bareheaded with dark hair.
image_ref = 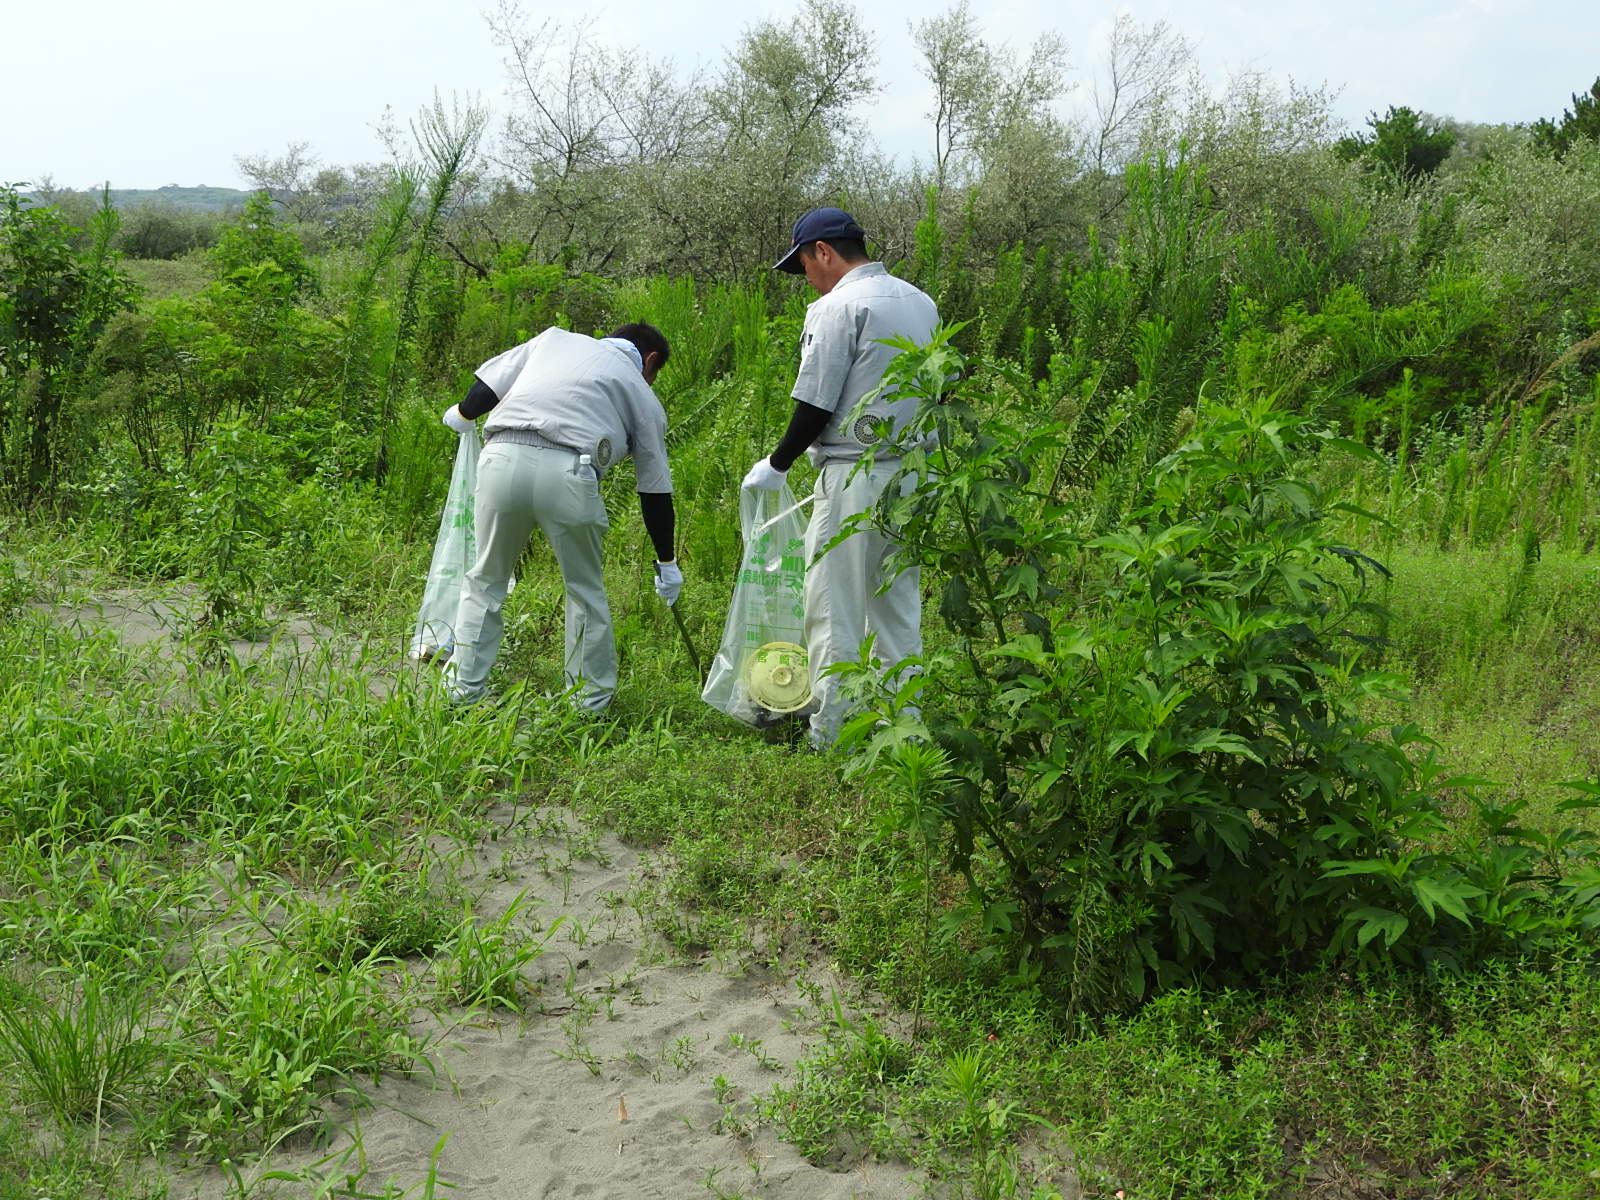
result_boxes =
[445,323,683,712]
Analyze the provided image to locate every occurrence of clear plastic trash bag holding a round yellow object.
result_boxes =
[701,483,811,728]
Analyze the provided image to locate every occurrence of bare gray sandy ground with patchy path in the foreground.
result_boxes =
[37,589,922,1200]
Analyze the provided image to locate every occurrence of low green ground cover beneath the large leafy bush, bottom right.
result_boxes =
[760,947,1600,1200]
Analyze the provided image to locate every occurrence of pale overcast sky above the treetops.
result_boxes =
[0,0,1600,187]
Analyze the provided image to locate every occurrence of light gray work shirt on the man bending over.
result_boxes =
[474,326,672,491]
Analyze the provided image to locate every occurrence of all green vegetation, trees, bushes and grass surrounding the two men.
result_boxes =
[0,0,1600,1200]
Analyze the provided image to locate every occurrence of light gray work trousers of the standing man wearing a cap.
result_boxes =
[805,461,922,749]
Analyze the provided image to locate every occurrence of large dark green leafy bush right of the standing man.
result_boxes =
[846,338,1600,1011]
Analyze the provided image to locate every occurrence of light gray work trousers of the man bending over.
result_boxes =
[446,442,616,712]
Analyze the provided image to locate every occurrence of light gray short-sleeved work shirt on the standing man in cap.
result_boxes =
[790,262,939,467]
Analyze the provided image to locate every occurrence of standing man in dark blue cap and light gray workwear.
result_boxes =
[744,208,939,749]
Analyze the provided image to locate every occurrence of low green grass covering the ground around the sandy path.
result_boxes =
[0,428,1600,1200]
